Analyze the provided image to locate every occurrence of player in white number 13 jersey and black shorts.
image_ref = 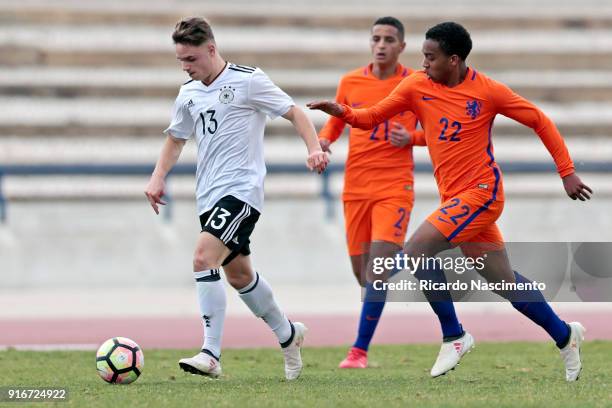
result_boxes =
[145,18,328,380]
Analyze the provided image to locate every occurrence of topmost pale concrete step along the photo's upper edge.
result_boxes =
[0,0,612,32]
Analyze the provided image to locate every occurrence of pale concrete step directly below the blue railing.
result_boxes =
[3,172,612,202]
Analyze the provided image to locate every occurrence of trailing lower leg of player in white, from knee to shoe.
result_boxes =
[223,254,307,380]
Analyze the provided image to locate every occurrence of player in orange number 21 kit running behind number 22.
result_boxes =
[319,17,425,368]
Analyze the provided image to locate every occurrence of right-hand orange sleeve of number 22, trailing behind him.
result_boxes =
[492,81,575,177]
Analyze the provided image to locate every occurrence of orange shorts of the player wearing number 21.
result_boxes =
[344,192,414,256]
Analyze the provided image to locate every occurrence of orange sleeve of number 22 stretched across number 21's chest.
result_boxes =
[340,75,415,130]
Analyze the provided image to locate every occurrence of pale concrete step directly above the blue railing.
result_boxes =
[0,135,612,165]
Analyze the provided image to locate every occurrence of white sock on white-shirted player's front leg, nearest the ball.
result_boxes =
[194,269,227,359]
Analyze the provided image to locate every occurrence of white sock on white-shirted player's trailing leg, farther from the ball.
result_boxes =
[238,272,292,346]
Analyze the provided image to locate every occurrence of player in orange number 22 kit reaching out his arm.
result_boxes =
[309,22,592,381]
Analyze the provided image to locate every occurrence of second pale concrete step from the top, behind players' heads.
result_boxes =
[0,26,612,70]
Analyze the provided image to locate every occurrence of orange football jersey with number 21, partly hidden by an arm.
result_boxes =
[319,64,425,201]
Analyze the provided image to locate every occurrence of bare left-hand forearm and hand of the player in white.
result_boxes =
[144,135,185,214]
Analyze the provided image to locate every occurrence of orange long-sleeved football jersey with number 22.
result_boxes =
[342,68,574,200]
